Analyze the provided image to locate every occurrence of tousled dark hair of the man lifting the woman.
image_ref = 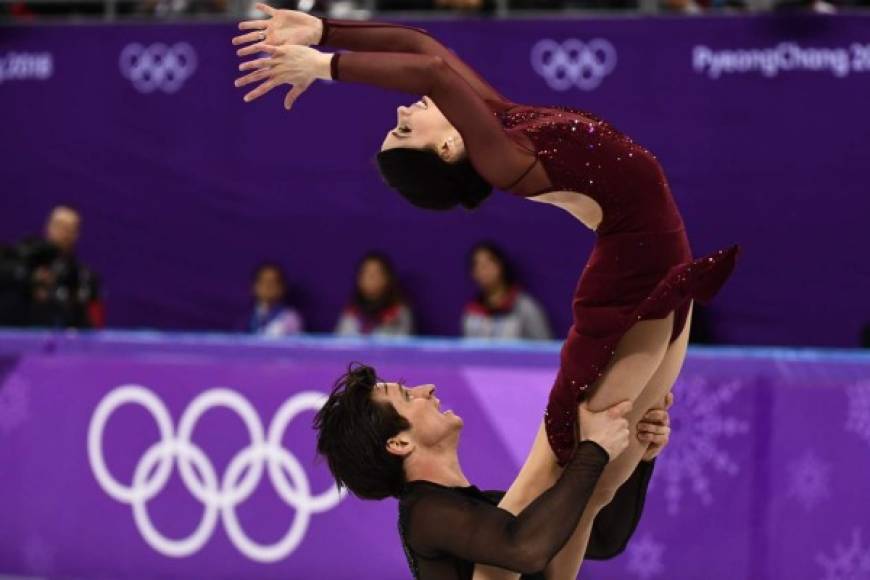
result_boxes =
[314,363,411,499]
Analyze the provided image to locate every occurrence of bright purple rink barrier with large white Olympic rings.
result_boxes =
[0,333,870,580]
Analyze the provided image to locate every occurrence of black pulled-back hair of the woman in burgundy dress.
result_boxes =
[377,147,492,210]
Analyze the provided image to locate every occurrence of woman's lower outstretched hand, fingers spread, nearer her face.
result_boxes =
[235,44,332,110]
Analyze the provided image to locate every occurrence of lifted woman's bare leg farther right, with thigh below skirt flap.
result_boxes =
[546,305,692,580]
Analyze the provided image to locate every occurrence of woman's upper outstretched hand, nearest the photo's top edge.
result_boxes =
[233,3,323,56]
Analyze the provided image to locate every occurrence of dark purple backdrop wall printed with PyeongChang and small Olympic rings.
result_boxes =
[0,14,870,347]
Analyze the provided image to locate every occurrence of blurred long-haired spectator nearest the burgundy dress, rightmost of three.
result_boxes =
[462,242,552,340]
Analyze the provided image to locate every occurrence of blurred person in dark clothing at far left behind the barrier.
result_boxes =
[0,205,105,328]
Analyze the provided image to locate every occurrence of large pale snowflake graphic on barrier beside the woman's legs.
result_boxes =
[650,376,749,515]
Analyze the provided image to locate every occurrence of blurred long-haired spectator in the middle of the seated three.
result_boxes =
[335,252,414,336]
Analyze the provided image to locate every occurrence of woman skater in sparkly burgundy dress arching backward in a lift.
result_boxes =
[233,5,738,579]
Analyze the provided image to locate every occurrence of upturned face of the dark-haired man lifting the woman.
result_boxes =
[372,383,462,448]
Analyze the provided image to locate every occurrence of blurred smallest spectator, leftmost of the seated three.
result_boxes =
[248,263,302,336]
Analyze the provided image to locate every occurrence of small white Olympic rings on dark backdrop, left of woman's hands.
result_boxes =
[118,42,197,93]
